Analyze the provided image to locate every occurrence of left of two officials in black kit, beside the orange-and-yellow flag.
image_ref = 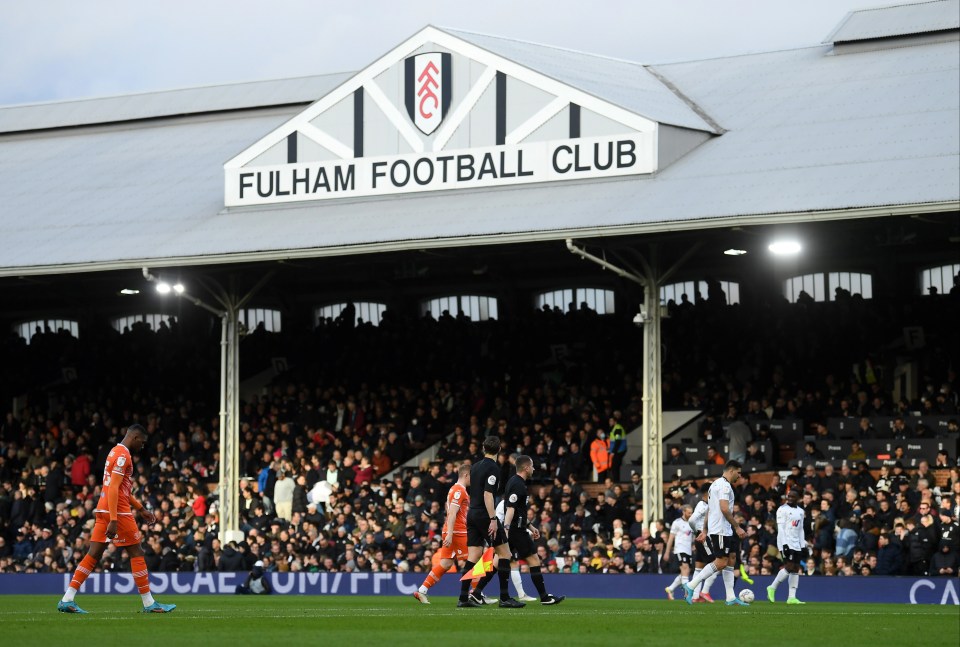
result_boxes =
[457,436,525,609]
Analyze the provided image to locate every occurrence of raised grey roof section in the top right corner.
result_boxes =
[825,0,960,43]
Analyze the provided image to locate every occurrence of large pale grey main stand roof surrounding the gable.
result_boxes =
[0,19,960,276]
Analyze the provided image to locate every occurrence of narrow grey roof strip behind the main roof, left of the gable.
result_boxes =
[0,72,353,133]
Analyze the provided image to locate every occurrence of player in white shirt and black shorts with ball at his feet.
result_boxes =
[683,460,750,606]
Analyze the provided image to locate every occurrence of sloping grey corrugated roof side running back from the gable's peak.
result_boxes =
[443,29,717,133]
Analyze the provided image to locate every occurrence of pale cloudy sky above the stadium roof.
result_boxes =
[0,0,903,105]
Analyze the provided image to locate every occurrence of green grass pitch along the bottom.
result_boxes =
[0,594,960,647]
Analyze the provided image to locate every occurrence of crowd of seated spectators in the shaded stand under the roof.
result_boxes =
[0,288,960,575]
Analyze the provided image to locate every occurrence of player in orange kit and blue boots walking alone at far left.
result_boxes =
[57,425,177,613]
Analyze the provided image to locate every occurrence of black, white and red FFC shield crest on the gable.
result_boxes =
[403,52,453,135]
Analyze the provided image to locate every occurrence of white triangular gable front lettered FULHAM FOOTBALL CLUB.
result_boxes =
[224,27,708,206]
